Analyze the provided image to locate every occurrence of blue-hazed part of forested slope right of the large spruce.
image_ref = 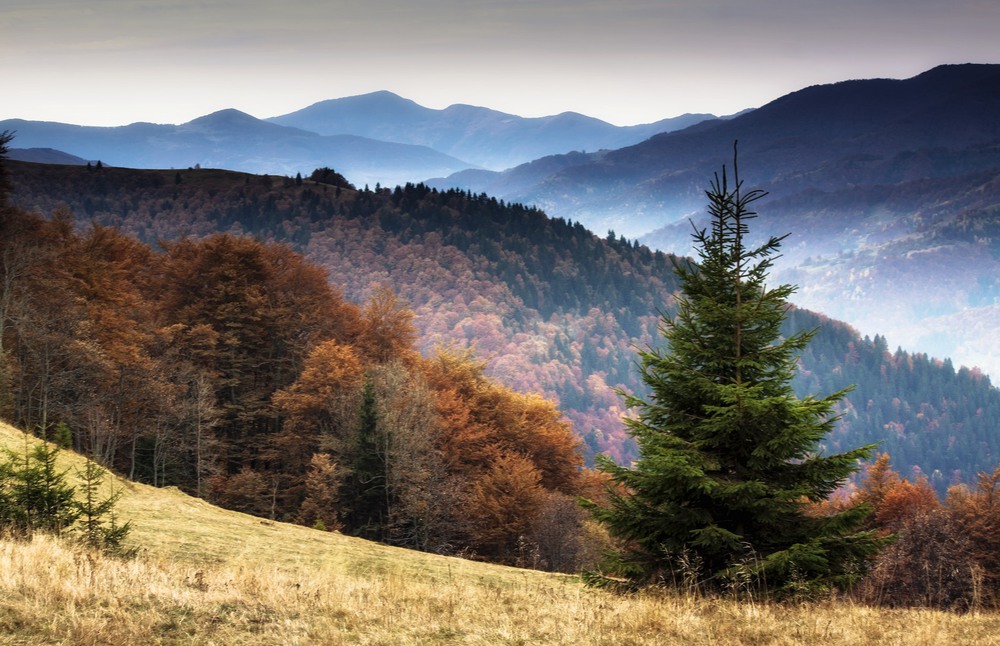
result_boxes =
[787,311,1000,495]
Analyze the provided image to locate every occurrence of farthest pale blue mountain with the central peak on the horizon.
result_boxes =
[268,91,714,170]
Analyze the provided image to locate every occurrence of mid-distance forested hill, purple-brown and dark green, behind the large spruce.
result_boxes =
[9,162,1000,486]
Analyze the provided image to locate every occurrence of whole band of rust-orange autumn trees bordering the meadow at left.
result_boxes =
[0,202,591,570]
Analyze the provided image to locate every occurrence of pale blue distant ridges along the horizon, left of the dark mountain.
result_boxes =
[0,92,712,186]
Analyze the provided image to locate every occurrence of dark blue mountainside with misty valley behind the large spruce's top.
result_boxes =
[430,64,1000,375]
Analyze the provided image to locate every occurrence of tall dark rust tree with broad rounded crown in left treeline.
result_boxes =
[158,235,360,474]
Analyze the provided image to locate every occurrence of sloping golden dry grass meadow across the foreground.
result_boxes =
[0,424,1000,646]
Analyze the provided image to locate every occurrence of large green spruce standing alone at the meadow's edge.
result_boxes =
[587,149,880,594]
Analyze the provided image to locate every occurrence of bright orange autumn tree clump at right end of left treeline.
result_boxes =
[423,349,590,570]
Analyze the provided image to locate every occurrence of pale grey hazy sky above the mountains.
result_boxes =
[0,0,1000,125]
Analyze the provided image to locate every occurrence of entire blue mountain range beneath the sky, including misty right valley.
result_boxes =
[0,64,1000,376]
